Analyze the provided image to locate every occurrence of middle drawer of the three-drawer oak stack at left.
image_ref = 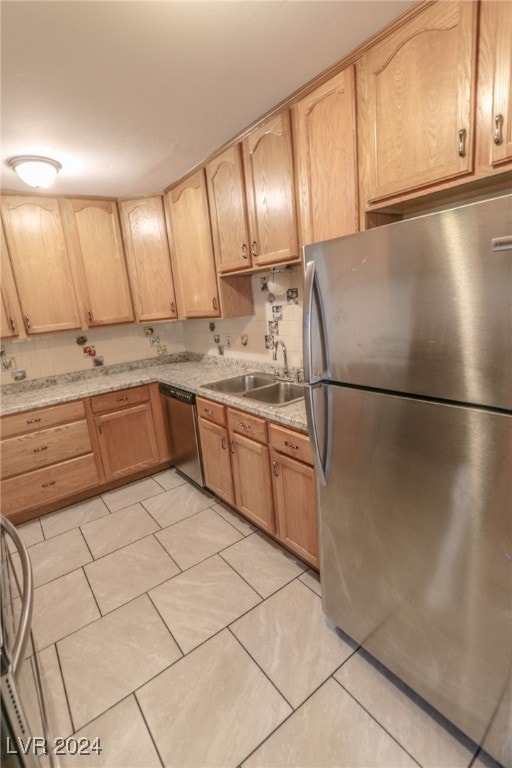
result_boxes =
[1,420,92,477]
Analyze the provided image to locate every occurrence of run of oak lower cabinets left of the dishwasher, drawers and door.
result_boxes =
[0,384,170,523]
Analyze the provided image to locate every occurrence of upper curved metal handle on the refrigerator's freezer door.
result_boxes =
[303,261,330,384]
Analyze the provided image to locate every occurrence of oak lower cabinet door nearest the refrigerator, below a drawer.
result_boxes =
[271,450,318,568]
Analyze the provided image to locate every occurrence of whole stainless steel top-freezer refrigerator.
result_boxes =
[304,195,512,768]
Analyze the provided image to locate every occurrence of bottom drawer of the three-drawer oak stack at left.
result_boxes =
[2,453,99,517]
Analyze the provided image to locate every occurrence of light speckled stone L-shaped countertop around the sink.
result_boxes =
[0,355,307,430]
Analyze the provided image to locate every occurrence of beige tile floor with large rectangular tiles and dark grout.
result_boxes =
[19,470,496,768]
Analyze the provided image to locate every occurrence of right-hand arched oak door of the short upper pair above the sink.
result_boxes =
[243,111,298,266]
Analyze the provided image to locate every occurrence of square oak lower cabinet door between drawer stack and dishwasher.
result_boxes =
[95,403,159,481]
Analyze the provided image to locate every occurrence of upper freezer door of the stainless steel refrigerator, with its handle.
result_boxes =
[304,195,512,409]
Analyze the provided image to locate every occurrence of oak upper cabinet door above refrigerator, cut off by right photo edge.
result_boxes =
[477,0,512,173]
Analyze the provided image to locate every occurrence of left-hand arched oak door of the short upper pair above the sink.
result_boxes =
[206,144,252,272]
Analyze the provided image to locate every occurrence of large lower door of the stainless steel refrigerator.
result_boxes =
[319,386,512,754]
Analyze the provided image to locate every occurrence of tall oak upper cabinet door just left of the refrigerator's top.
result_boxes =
[292,66,359,245]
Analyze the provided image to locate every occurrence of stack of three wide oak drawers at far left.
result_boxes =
[1,400,99,522]
